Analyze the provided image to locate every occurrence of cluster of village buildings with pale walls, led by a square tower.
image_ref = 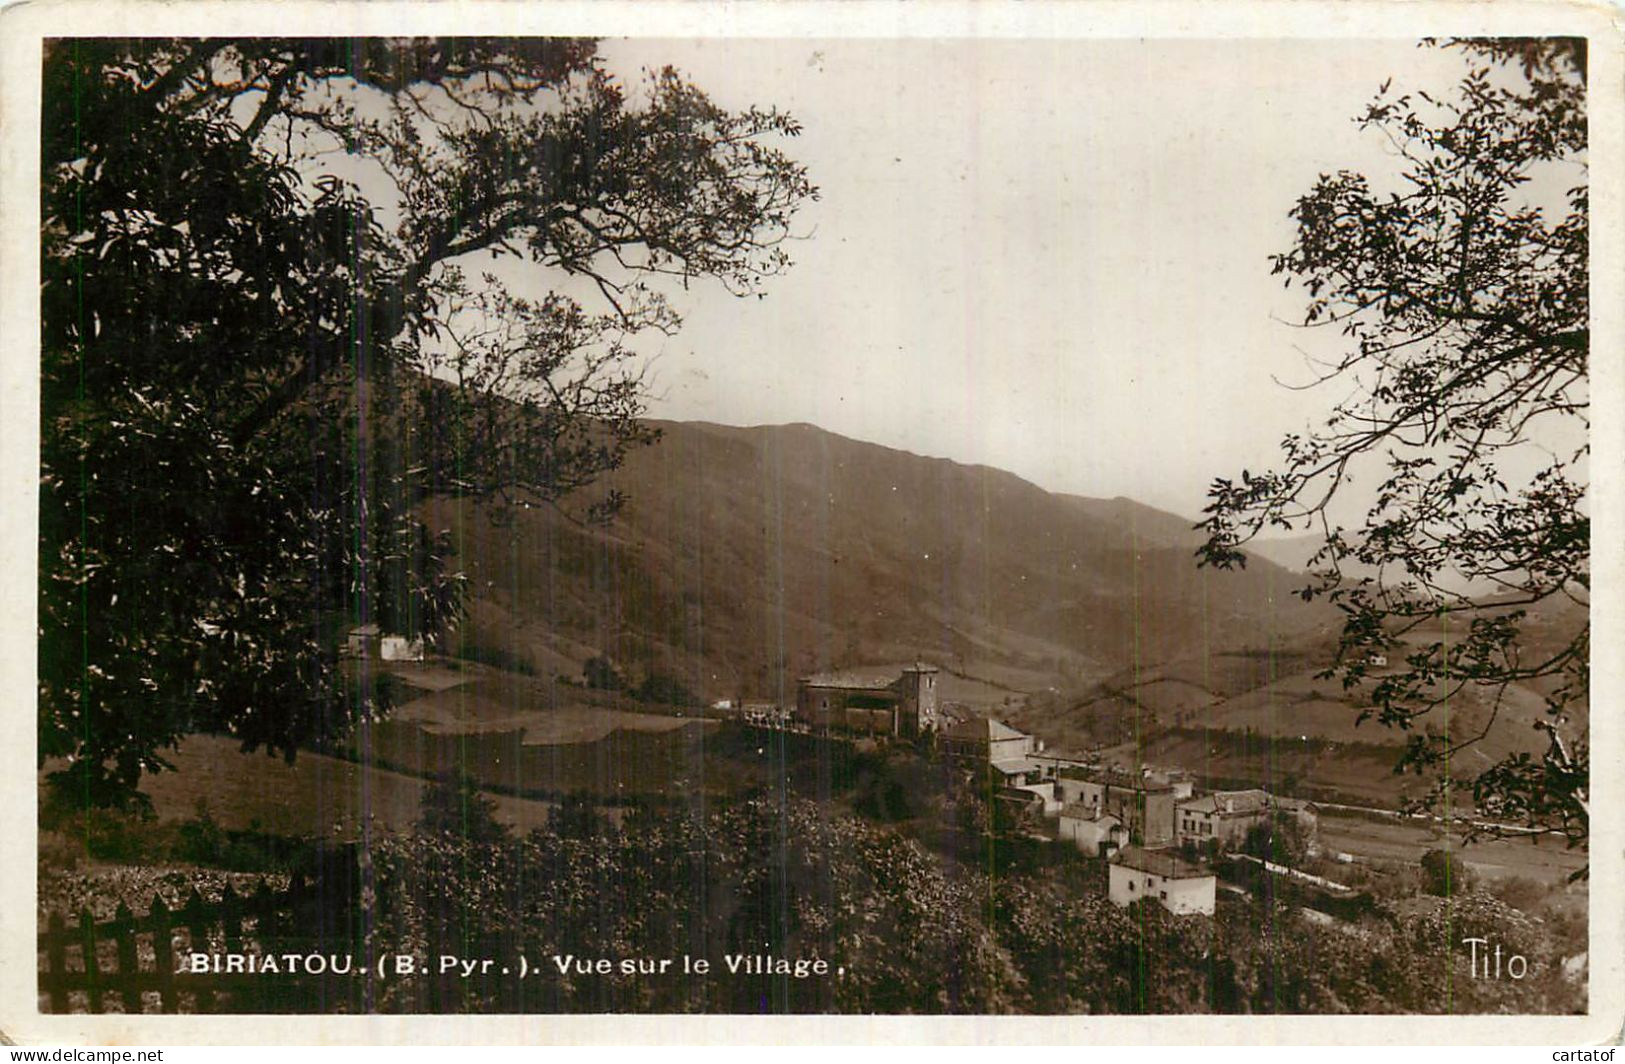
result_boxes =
[731,661,1367,916]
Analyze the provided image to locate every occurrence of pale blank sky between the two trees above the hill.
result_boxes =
[578,39,1482,515]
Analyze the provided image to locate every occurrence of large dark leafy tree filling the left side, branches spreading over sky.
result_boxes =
[39,39,816,802]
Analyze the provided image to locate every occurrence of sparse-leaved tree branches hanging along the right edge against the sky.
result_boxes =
[1199,39,1591,845]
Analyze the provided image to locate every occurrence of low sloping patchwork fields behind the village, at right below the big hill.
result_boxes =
[1004,599,1586,804]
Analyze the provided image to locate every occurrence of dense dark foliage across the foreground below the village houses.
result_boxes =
[359,796,1584,1015]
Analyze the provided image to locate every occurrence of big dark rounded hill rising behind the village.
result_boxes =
[426,422,1334,697]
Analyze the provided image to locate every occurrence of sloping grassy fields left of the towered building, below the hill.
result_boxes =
[46,663,762,857]
